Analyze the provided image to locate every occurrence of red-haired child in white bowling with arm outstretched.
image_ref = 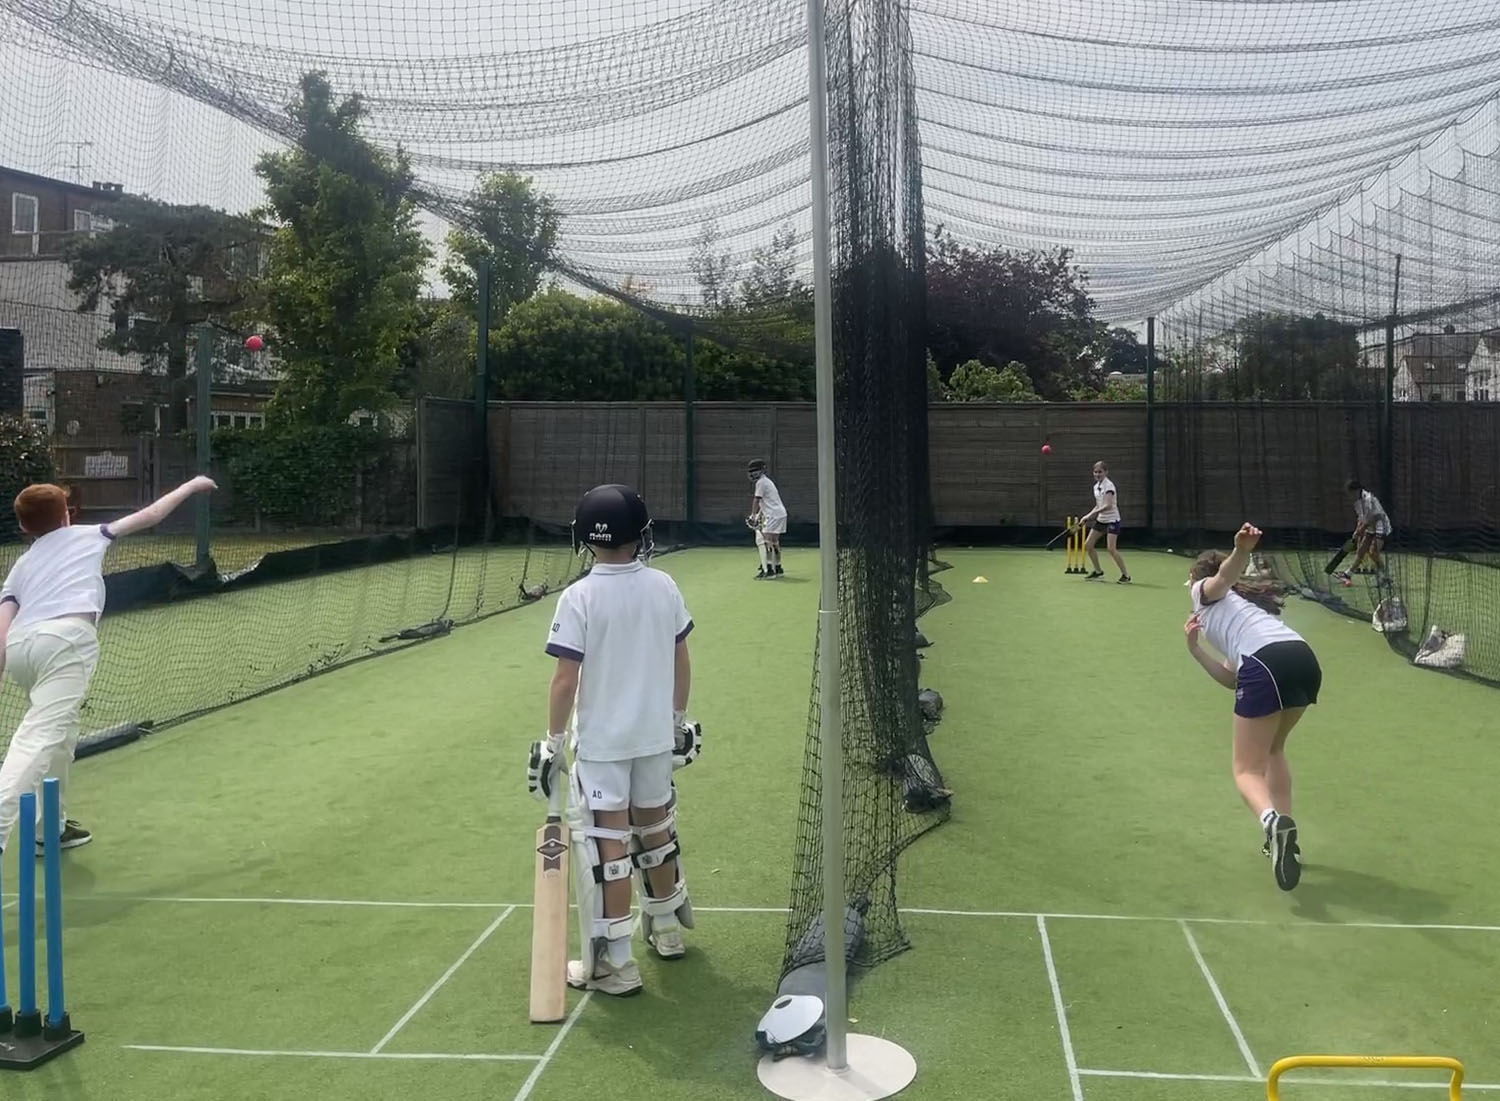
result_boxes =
[0,477,215,849]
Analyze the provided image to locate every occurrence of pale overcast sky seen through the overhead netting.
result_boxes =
[0,0,1500,326]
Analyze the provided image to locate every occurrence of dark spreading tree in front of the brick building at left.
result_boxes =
[68,195,266,432]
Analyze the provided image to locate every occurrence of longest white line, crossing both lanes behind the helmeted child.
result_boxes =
[55,894,1500,933]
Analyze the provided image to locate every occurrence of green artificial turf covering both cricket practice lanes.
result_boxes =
[0,549,1500,1101]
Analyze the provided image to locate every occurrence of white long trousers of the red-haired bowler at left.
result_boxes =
[0,617,99,855]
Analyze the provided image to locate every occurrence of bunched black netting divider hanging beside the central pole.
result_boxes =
[783,2,947,975]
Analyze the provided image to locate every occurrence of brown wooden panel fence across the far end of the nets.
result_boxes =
[462,402,1500,531]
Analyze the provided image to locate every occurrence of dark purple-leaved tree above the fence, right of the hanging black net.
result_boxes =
[927,228,1101,401]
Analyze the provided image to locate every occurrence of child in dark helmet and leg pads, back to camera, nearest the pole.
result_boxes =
[528,486,701,998]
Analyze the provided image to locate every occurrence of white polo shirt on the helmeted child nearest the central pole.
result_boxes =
[546,561,693,761]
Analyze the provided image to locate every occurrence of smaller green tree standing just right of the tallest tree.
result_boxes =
[443,173,558,327]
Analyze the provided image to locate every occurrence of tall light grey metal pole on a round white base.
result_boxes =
[759,0,917,1101]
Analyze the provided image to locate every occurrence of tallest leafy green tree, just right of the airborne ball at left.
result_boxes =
[255,72,429,425]
